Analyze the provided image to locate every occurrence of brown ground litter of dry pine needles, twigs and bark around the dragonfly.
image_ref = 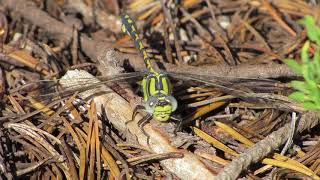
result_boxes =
[0,0,320,179]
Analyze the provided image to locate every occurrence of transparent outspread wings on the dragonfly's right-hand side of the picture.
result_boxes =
[167,72,293,111]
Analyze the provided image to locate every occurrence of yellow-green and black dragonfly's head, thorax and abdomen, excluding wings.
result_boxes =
[121,14,178,122]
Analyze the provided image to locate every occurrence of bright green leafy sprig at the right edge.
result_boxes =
[284,16,320,109]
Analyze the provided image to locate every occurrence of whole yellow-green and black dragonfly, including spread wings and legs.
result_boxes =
[6,14,292,136]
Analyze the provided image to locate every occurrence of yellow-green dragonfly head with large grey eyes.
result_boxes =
[146,95,178,122]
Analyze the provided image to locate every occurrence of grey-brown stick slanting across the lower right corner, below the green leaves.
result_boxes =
[216,111,320,180]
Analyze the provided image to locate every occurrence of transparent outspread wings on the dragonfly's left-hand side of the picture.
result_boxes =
[0,71,146,122]
